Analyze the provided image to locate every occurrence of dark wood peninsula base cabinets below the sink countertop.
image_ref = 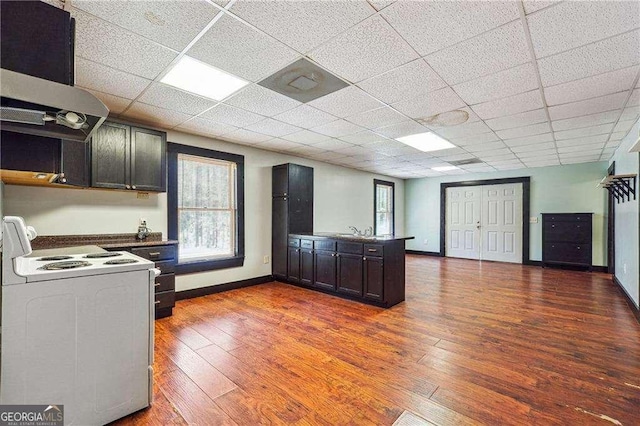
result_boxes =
[285,234,405,307]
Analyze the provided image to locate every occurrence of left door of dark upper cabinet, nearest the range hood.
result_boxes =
[91,123,130,189]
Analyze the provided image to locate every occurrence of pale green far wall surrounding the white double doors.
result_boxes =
[405,162,608,266]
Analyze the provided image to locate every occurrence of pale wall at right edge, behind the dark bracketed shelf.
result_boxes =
[611,120,640,307]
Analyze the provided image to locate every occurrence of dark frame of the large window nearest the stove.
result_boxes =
[167,142,245,275]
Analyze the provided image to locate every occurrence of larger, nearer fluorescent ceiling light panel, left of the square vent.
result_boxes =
[160,56,249,101]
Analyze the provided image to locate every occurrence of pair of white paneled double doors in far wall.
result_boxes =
[445,183,522,263]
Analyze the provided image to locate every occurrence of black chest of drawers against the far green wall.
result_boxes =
[542,213,593,271]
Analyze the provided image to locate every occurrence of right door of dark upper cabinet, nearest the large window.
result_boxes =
[131,127,167,192]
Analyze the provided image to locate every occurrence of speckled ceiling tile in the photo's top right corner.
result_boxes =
[527,1,640,58]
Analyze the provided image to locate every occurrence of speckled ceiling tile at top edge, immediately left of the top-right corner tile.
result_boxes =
[381,1,519,56]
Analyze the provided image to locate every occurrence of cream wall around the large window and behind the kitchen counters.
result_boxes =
[3,131,404,291]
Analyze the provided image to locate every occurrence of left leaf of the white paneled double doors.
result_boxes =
[445,186,482,259]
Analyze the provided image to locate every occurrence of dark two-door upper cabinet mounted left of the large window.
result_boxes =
[91,122,167,192]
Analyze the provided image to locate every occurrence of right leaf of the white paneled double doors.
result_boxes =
[480,183,522,263]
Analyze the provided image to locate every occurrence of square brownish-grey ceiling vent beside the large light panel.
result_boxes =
[258,58,348,103]
